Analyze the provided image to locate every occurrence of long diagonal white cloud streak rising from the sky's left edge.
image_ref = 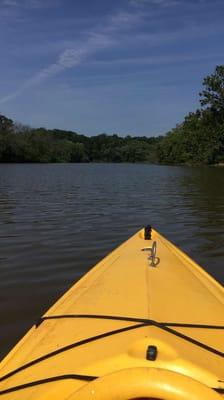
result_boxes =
[0,7,140,104]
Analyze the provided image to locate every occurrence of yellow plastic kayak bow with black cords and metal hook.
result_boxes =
[0,227,224,400]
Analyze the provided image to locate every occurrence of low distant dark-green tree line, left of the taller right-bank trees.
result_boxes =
[0,115,159,163]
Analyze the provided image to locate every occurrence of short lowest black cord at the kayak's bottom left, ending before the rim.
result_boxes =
[0,374,98,396]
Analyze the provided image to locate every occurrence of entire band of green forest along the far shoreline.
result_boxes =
[0,65,224,165]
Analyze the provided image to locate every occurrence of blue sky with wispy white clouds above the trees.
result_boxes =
[0,0,224,136]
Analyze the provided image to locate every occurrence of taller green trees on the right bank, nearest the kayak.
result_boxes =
[157,65,224,165]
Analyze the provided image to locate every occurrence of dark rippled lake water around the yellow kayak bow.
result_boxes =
[0,164,224,356]
